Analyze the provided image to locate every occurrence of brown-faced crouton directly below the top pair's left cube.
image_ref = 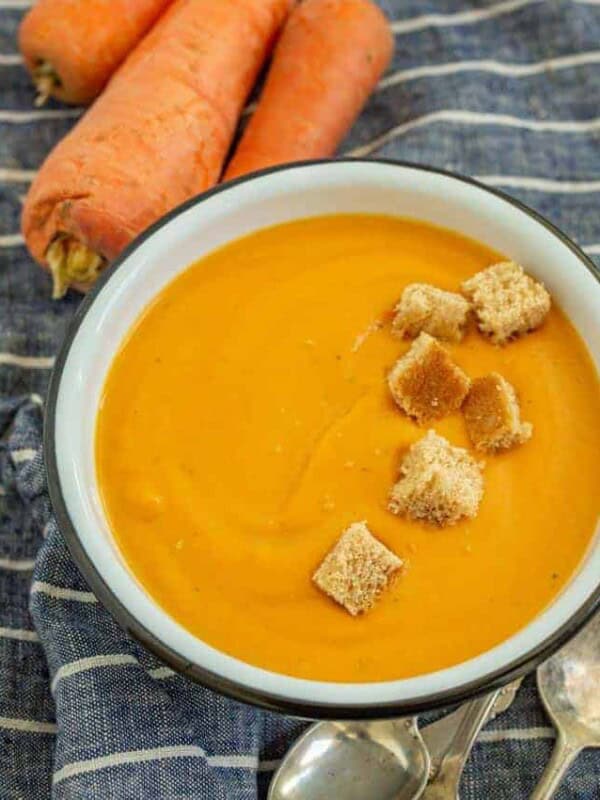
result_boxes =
[388,333,471,423]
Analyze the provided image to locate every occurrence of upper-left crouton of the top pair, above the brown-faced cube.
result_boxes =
[392,283,471,342]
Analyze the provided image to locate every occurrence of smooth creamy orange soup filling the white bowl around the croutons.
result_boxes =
[97,216,600,681]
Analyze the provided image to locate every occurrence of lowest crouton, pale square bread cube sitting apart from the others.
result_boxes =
[313,522,402,617]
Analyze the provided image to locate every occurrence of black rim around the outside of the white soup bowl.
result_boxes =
[44,158,600,719]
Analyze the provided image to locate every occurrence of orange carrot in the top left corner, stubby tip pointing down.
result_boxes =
[19,0,172,105]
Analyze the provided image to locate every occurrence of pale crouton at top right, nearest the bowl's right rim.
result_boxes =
[461,261,550,344]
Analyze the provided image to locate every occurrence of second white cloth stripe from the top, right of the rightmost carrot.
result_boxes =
[377,50,600,90]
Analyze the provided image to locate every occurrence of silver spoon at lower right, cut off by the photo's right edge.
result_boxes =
[531,614,600,800]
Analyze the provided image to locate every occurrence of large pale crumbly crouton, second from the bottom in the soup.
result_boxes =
[388,430,483,527]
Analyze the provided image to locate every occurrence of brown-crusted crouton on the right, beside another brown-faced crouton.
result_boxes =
[463,372,533,452]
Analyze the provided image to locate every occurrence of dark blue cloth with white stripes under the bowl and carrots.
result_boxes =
[0,0,600,800]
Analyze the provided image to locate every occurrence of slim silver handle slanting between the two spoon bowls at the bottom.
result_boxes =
[423,691,499,800]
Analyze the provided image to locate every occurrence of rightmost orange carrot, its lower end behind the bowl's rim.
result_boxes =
[225,0,394,179]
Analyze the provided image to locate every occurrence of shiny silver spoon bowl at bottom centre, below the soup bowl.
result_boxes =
[269,718,430,800]
